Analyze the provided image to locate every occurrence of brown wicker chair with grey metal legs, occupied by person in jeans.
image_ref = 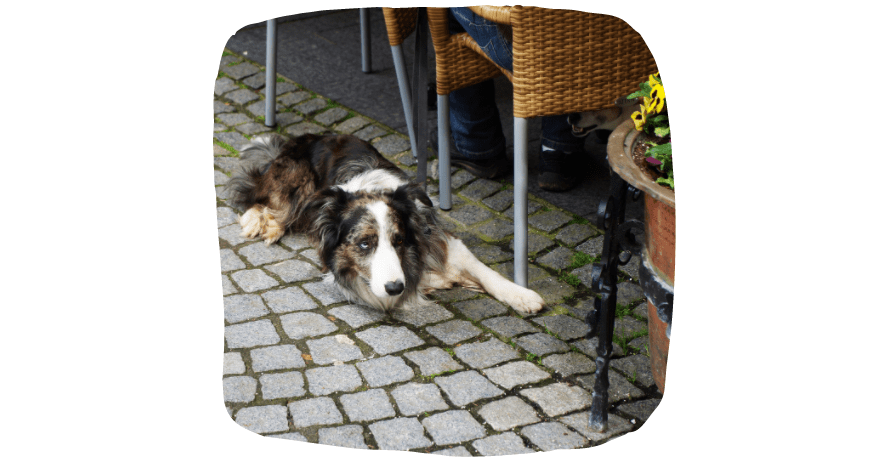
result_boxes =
[428,6,656,287]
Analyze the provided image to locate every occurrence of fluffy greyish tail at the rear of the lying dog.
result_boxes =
[226,135,286,211]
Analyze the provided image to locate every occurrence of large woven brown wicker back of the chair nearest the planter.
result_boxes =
[511,7,656,118]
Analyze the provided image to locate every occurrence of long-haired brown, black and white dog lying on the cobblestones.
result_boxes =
[227,134,545,312]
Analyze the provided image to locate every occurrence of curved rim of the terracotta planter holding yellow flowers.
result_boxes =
[606,119,675,208]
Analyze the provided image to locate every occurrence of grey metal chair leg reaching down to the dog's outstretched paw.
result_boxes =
[514,117,529,287]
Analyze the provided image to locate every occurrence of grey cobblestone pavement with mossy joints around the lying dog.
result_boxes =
[213,51,661,456]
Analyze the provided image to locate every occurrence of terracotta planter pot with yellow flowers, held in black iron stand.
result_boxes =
[607,120,675,392]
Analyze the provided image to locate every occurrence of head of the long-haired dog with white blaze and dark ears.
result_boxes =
[312,184,432,311]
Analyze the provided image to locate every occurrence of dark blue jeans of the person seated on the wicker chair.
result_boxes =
[449,8,585,159]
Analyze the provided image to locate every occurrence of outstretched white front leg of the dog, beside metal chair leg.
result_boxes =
[446,237,545,313]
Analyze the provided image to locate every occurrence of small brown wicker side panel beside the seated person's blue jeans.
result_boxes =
[427,8,502,95]
